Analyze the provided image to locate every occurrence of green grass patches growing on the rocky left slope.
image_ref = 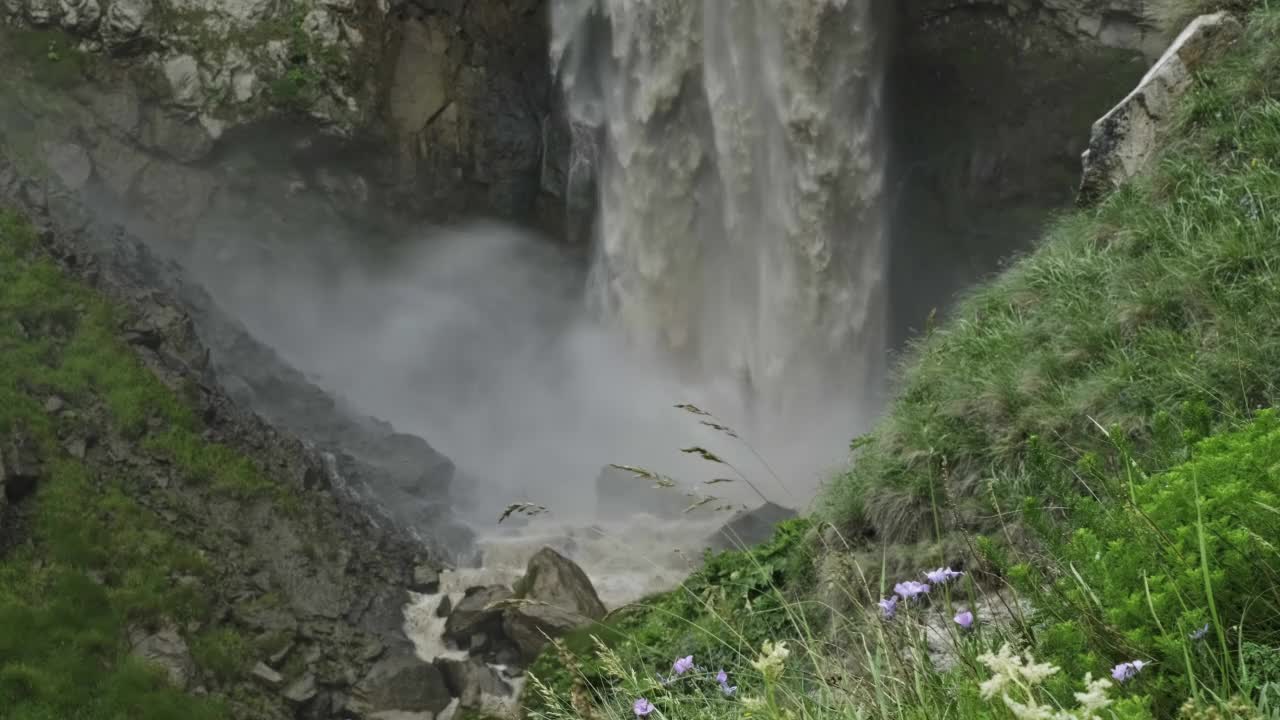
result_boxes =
[0,211,299,720]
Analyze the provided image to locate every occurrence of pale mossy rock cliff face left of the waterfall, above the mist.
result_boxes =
[0,0,559,222]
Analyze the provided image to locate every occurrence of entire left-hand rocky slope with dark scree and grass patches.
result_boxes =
[0,178,448,719]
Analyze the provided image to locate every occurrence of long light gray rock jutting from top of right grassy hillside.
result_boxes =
[1078,13,1243,205]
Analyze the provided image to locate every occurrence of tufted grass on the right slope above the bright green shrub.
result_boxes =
[824,2,1280,542]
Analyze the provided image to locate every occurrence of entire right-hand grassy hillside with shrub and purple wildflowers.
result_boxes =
[529,1,1280,720]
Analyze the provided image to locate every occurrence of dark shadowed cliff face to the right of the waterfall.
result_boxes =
[890,0,1166,340]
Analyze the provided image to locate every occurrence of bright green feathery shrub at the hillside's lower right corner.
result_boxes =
[1014,410,1280,712]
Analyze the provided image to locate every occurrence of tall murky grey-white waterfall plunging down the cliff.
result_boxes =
[552,0,887,420]
